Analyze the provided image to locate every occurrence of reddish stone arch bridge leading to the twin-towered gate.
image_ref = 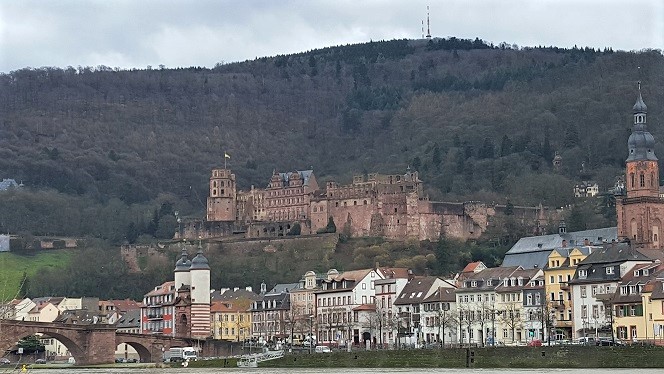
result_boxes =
[0,320,192,365]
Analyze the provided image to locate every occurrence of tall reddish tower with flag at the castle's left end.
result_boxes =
[206,168,236,222]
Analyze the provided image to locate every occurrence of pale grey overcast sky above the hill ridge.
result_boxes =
[0,0,664,73]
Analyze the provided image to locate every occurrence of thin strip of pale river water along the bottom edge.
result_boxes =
[18,368,662,374]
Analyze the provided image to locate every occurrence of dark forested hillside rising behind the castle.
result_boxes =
[0,38,664,240]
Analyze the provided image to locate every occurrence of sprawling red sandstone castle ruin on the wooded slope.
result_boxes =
[176,168,549,240]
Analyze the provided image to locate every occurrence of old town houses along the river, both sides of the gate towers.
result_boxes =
[2,237,664,350]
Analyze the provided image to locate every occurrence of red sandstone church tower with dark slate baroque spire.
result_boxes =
[616,82,664,249]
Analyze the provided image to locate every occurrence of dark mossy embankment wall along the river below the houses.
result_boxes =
[190,345,664,368]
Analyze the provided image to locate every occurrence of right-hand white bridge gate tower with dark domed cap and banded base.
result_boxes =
[189,243,210,339]
